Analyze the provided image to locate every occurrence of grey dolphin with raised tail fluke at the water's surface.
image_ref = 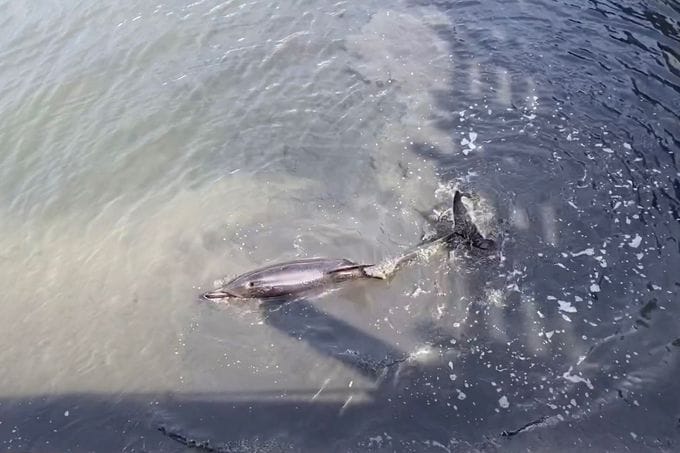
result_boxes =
[202,191,494,300]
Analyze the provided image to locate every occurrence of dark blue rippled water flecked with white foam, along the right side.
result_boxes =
[396,1,680,451]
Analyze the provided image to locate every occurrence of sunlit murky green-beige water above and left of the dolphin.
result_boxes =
[0,2,448,394]
